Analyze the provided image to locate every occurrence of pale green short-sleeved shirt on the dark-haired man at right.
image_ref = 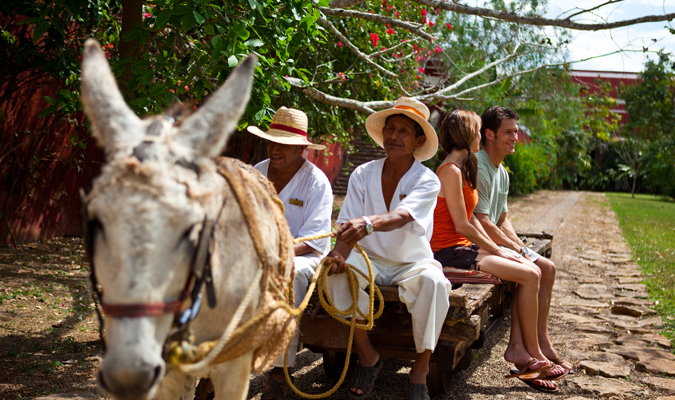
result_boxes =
[473,150,509,225]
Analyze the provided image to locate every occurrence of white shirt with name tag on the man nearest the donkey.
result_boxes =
[253,159,333,255]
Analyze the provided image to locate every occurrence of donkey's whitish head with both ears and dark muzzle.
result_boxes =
[82,39,256,399]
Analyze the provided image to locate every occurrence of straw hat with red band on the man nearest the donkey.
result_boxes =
[246,107,326,150]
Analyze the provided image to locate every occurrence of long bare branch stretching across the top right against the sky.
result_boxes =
[411,0,675,31]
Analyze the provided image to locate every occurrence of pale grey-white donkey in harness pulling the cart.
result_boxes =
[82,39,293,400]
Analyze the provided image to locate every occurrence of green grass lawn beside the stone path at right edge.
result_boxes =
[606,193,675,339]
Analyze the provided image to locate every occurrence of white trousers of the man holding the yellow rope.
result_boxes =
[326,251,452,353]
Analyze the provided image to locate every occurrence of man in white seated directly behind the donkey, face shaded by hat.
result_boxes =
[247,107,333,399]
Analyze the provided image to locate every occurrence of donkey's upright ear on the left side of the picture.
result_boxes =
[82,39,143,158]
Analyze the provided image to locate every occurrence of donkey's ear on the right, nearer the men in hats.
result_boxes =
[176,55,258,158]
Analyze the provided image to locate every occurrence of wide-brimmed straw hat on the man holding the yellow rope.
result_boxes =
[366,97,438,161]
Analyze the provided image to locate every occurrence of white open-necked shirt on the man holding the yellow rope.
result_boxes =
[337,158,441,266]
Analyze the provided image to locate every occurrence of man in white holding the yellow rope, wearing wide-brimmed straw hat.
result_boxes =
[327,97,451,400]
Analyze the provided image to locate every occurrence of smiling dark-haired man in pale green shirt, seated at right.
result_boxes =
[474,106,572,391]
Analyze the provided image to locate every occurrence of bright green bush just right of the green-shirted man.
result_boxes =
[504,143,554,195]
